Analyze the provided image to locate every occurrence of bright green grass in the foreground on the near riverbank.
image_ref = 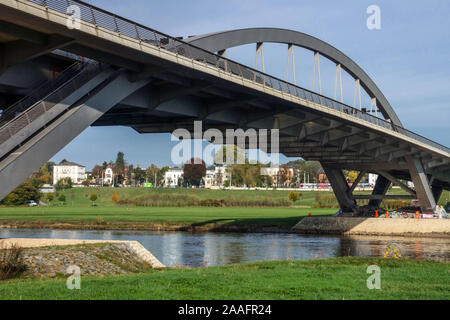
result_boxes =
[0,258,450,300]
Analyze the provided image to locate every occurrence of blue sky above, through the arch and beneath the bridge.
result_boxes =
[52,0,450,169]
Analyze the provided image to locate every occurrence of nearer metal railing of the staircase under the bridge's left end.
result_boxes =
[0,62,103,145]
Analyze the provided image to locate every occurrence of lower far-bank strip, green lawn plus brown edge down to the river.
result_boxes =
[0,206,336,232]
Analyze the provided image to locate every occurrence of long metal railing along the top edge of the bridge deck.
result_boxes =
[28,0,450,153]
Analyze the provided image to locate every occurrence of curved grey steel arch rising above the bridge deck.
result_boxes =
[185,28,403,127]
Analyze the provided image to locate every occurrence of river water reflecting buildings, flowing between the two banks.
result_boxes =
[0,229,450,267]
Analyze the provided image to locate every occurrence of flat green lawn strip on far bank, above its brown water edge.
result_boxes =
[0,206,336,229]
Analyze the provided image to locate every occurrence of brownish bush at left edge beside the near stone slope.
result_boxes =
[0,245,27,280]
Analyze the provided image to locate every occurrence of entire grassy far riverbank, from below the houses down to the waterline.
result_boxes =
[0,187,412,232]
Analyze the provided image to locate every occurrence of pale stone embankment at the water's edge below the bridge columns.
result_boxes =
[292,217,450,237]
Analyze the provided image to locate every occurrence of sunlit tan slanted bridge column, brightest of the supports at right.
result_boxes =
[406,157,436,210]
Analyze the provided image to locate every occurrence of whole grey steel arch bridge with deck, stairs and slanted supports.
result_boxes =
[0,0,450,212]
